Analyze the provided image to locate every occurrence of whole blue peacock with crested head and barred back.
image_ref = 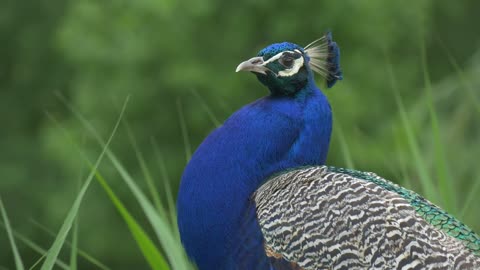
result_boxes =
[177,33,480,270]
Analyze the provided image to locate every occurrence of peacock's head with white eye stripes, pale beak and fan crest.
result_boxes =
[236,32,343,96]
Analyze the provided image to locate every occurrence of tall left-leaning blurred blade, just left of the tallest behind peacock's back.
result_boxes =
[386,55,438,202]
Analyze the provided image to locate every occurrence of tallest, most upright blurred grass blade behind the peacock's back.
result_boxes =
[421,39,456,213]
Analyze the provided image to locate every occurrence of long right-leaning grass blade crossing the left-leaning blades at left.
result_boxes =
[40,97,129,270]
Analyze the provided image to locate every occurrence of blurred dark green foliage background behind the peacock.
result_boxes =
[0,0,480,269]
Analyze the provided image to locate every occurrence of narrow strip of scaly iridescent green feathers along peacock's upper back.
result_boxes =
[328,167,480,255]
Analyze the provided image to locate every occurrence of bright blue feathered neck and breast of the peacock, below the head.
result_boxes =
[177,76,332,269]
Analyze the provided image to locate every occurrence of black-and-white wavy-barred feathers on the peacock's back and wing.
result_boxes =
[253,166,480,270]
